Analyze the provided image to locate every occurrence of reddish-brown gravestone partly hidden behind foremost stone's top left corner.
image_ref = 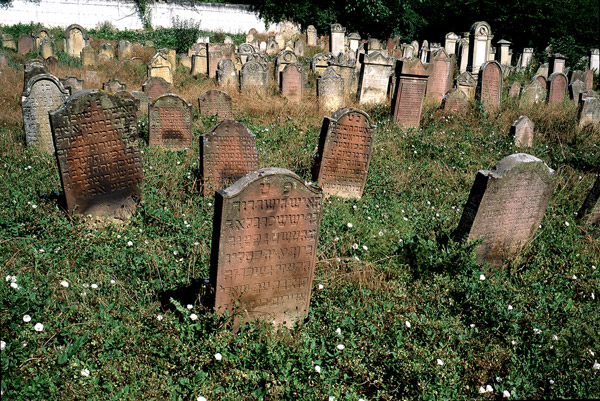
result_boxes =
[200,120,258,197]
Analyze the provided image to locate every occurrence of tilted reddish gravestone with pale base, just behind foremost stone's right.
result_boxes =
[313,107,375,198]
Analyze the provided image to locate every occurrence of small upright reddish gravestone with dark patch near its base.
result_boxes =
[148,93,192,150]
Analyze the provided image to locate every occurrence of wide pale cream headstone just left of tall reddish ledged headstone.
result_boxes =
[358,51,394,104]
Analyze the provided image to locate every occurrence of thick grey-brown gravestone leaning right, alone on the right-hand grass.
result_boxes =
[453,153,554,266]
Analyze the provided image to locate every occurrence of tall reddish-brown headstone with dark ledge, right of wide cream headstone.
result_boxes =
[392,59,429,128]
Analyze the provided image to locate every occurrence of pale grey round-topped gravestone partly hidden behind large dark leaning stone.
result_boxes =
[21,74,69,154]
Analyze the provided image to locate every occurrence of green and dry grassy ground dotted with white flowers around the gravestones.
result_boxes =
[0,26,600,400]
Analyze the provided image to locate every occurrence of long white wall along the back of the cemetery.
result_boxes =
[0,0,276,33]
